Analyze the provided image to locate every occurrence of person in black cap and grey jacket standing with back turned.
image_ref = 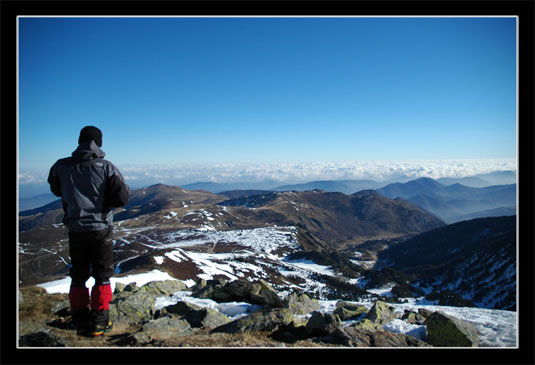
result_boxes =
[48,126,130,336]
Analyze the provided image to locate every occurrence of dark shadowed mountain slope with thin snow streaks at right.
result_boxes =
[378,216,517,310]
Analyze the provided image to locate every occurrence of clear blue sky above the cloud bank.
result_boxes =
[18,18,517,169]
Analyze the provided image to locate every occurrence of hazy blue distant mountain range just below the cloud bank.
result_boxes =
[19,172,516,230]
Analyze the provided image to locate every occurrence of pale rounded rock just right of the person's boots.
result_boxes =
[131,316,193,344]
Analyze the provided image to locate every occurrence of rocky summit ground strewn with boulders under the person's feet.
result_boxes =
[19,280,478,348]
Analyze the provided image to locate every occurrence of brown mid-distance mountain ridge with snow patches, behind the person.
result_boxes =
[19,184,444,281]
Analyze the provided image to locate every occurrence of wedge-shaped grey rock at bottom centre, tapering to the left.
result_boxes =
[212,308,293,333]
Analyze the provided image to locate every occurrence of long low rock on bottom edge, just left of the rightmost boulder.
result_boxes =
[328,325,430,347]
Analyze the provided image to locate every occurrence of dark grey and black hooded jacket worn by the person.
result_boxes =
[48,141,130,232]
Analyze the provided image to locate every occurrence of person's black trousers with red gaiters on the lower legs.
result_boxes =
[69,227,114,310]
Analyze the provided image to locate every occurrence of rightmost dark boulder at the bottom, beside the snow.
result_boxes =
[424,311,479,347]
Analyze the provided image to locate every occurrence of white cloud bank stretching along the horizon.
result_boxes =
[19,159,517,186]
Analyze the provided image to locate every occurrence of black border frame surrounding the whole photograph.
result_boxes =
[0,0,535,364]
